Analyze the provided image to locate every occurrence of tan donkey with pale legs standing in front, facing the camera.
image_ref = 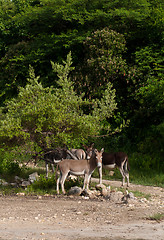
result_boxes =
[56,148,104,194]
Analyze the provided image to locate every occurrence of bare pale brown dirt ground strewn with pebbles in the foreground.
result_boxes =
[0,181,164,240]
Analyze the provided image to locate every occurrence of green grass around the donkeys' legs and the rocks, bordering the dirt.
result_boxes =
[0,163,164,199]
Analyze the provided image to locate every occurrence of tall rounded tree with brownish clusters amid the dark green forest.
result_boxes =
[73,28,127,98]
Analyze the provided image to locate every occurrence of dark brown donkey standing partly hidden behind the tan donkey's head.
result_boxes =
[87,144,130,187]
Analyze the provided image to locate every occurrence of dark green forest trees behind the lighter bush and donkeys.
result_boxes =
[0,0,164,178]
